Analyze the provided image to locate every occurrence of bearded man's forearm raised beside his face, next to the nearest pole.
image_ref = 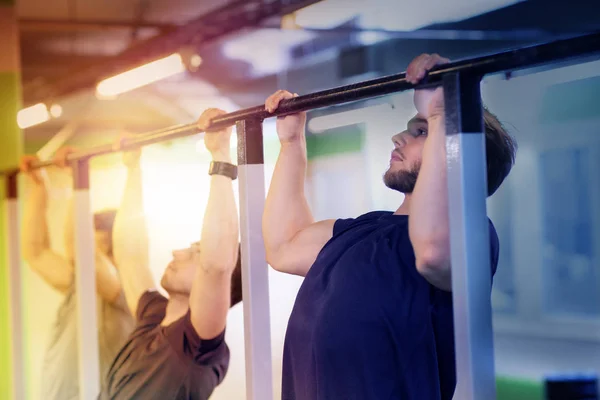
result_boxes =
[409,115,450,268]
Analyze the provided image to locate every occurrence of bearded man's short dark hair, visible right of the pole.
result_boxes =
[483,107,517,196]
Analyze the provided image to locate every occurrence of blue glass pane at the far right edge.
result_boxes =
[540,148,600,316]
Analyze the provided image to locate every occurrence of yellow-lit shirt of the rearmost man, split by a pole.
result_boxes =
[41,286,135,400]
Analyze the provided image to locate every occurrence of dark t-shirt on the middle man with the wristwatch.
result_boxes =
[98,291,229,400]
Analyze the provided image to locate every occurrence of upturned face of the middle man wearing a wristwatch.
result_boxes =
[160,245,199,295]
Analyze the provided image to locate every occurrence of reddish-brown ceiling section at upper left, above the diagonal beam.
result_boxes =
[17,0,227,91]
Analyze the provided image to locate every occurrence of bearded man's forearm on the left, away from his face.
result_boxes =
[263,137,314,258]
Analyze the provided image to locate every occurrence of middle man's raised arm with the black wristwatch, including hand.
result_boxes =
[190,109,239,339]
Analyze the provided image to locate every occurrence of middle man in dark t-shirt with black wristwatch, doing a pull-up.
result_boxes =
[100,109,241,400]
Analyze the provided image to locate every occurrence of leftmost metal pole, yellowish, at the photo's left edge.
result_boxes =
[5,174,25,399]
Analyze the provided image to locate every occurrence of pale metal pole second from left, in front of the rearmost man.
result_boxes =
[72,159,100,400]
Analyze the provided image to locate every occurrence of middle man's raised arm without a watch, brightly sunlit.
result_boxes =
[113,141,156,315]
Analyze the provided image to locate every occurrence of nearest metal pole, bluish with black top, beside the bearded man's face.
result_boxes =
[444,73,496,400]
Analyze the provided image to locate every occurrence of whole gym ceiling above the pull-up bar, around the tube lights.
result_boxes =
[17,0,600,155]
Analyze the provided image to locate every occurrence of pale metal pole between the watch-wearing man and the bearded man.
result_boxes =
[236,120,273,400]
